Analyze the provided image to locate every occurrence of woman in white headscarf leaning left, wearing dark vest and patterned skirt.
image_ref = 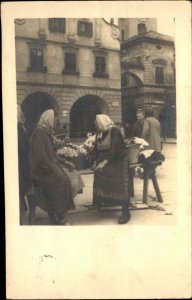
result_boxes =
[90,114,130,224]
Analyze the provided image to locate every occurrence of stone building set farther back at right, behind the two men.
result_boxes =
[119,19,176,136]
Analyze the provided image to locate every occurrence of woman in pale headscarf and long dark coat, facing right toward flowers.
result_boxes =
[30,109,75,225]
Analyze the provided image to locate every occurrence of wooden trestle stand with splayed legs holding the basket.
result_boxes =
[128,160,163,204]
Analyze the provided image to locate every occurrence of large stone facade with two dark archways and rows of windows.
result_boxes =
[15,18,121,137]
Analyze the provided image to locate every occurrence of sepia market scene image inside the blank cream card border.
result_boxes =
[15,18,177,225]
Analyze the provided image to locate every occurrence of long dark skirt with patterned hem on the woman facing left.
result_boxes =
[93,159,129,205]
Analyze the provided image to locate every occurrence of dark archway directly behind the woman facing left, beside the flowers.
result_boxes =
[70,95,109,138]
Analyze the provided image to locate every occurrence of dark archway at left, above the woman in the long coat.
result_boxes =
[22,92,58,135]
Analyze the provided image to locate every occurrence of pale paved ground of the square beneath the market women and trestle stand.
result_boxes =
[33,143,176,226]
